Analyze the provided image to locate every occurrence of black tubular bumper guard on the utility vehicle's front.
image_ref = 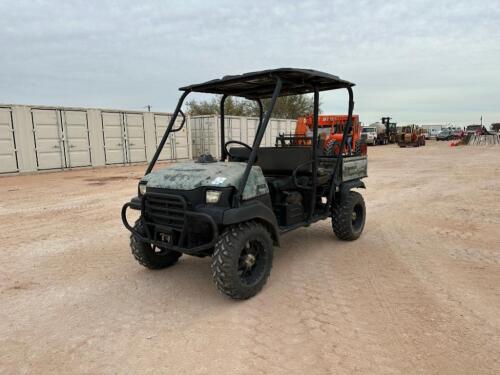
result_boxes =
[121,193,219,255]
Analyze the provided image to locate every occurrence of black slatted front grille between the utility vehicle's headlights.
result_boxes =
[144,193,186,230]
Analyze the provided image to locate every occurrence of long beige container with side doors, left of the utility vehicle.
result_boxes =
[0,105,191,173]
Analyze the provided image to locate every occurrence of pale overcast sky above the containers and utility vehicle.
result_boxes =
[0,0,500,124]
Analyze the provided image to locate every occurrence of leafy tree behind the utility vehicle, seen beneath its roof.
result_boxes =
[186,95,321,119]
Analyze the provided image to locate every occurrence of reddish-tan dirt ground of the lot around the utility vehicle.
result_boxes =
[0,141,500,374]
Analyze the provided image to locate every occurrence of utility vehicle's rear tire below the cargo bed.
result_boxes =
[332,191,366,241]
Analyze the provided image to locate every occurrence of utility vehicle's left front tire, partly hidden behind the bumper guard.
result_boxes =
[130,220,182,270]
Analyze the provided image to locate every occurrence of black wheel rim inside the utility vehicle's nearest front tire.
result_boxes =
[238,240,267,286]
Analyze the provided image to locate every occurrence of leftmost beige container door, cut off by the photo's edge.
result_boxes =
[0,108,19,173]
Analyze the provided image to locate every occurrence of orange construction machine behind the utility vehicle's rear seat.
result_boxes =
[295,115,366,155]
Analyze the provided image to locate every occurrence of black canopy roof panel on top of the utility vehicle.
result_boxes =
[179,68,354,99]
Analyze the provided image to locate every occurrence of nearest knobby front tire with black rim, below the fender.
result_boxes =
[212,221,273,300]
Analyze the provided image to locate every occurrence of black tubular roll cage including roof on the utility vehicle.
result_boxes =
[145,68,354,221]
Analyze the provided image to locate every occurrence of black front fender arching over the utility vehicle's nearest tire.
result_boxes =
[222,200,280,246]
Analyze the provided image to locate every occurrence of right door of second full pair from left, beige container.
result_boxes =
[123,113,146,163]
